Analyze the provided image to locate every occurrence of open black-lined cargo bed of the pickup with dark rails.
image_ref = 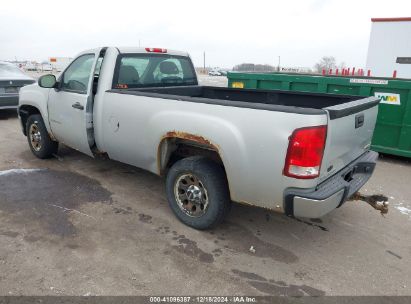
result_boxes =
[109,86,378,119]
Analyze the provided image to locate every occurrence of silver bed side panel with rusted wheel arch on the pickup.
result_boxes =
[95,92,327,211]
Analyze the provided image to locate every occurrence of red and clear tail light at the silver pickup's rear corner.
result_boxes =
[283,126,327,179]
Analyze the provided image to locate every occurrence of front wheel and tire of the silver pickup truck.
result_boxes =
[26,114,58,159]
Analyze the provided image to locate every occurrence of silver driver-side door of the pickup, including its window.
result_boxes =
[48,51,99,156]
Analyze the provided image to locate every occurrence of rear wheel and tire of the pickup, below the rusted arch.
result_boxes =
[166,156,231,230]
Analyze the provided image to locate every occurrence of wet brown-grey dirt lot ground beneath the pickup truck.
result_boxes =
[0,78,411,295]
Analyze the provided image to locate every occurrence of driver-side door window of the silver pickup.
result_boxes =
[61,54,94,94]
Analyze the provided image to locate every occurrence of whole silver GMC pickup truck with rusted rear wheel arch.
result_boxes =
[18,47,379,229]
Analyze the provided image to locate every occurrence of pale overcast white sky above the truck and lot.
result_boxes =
[0,0,411,67]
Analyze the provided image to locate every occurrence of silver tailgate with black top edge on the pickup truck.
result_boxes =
[320,97,380,181]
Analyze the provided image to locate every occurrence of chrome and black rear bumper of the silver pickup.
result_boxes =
[284,151,378,218]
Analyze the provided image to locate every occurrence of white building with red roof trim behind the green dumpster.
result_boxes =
[367,17,411,78]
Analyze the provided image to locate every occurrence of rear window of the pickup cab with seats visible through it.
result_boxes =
[113,54,197,89]
